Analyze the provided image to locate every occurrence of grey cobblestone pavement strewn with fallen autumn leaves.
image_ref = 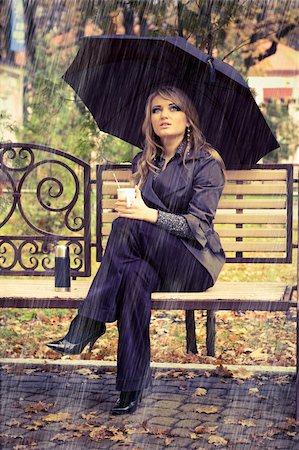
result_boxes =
[0,363,299,450]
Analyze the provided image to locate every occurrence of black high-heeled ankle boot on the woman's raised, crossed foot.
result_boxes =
[46,316,106,355]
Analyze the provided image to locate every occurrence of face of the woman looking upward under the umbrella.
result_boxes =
[151,95,189,143]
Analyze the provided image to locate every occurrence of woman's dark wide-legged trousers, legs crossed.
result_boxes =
[79,218,213,391]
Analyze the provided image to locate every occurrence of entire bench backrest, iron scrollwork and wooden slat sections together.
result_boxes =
[0,143,298,276]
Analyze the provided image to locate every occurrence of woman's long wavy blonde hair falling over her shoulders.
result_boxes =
[133,86,225,186]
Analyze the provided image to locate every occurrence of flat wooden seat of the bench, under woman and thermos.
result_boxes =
[0,278,297,311]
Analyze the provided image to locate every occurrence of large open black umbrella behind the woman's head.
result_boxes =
[64,36,279,168]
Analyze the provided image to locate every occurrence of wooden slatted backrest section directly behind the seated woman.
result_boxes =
[98,164,293,263]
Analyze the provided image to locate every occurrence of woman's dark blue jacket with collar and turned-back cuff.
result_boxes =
[132,151,225,282]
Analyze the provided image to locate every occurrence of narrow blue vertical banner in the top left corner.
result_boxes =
[10,0,25,52]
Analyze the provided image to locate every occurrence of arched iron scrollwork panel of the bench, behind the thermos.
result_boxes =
[0,144,91,276]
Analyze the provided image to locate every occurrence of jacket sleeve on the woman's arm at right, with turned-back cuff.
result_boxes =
[184,155,225,252]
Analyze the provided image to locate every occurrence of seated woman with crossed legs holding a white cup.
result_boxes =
[48,87,225,414]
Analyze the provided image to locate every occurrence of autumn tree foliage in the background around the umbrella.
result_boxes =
[0,0,299,161]
